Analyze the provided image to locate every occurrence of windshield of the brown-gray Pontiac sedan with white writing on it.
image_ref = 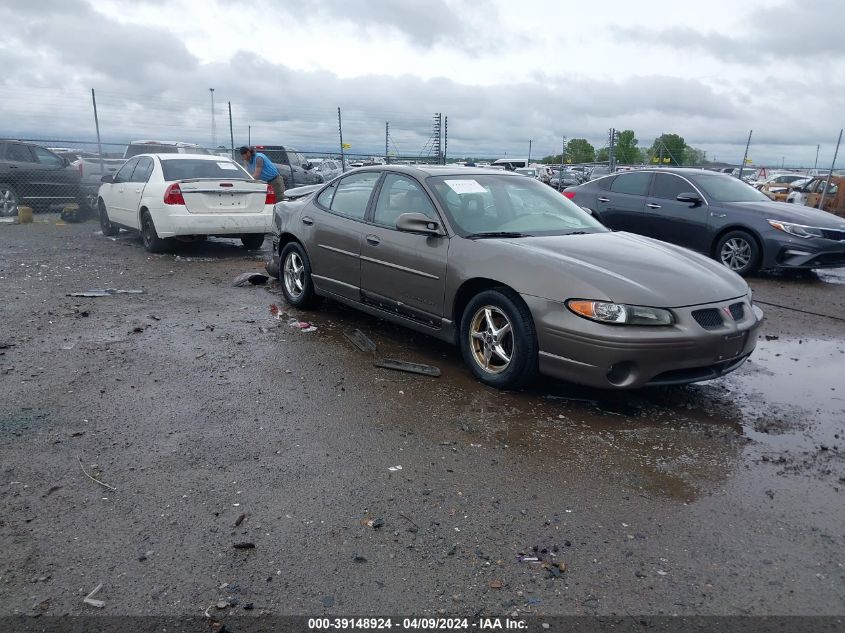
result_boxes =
[428,174,607,237]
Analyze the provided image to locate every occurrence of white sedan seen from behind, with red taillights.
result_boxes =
[98,154,276,253]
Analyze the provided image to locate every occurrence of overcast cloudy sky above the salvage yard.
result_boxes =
[0,0,845,166]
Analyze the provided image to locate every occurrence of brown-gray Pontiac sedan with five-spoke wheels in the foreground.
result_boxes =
[268,165,762,389]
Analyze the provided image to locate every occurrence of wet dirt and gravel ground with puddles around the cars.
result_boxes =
[0,216,845,616]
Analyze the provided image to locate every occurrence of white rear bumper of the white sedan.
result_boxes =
[150,206,273,238]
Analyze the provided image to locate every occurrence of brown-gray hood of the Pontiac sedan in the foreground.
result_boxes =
[498,232,748,308]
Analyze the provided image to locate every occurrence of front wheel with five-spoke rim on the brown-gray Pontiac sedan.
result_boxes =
[460,288,538,389]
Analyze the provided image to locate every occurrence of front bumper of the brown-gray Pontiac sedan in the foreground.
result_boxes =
[523,296,763,389]
